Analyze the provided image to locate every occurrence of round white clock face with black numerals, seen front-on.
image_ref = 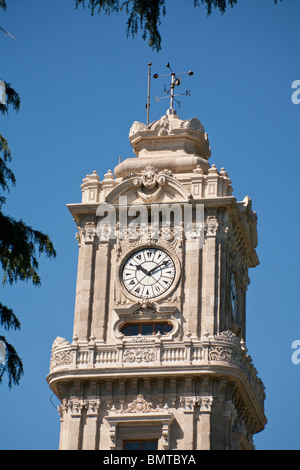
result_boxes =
[122,248,175,299]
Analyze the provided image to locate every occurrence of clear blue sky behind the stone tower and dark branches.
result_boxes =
[0,0,300,450]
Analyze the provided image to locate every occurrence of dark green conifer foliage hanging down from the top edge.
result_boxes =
[75,0,282,51]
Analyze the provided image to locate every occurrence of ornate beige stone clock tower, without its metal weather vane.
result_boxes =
[47,109,266,451]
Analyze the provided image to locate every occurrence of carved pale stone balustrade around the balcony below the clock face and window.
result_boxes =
[50,332,265,406]
